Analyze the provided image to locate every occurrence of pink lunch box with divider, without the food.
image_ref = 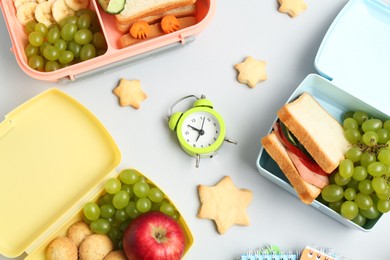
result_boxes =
[0,0,215,83]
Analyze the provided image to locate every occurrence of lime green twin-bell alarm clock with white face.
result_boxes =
[168,95,237,167]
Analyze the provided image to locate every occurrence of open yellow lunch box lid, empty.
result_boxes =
[0,88,121,257]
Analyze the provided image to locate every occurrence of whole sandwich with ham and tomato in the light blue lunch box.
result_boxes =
[261,92,351,204]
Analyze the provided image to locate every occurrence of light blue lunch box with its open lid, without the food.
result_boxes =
[256,0,390,231]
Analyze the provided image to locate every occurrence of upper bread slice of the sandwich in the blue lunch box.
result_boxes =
[277,92,351,173]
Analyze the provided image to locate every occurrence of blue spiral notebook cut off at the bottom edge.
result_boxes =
[239,246,299,260]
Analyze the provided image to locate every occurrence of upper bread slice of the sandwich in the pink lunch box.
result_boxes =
[115,0,196,24]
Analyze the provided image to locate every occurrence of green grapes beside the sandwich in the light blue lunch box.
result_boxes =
[322,111,390,226]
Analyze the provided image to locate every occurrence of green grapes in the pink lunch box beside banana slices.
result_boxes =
[25,9,107,72]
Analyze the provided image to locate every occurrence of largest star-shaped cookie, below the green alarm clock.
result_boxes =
[198,176,252,234]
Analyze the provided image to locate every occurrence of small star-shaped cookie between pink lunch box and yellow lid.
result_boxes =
[113,78,147,109]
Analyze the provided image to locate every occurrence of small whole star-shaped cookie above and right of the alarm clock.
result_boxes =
[234,56,267,88]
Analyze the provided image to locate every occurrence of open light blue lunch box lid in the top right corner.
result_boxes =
[314,0,390,115]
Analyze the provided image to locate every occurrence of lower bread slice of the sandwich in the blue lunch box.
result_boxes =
[261,132,321,204]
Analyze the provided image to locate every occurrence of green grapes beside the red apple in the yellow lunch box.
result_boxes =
[83,169,180,248]
